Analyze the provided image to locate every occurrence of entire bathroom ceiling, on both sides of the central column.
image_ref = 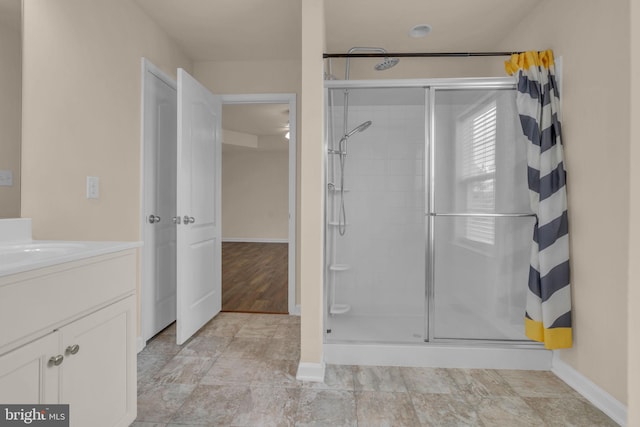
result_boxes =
[134,0,541,61]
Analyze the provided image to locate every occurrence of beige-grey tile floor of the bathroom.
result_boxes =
[132,313,617,427]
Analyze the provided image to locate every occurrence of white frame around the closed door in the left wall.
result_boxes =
[137,58,178,352]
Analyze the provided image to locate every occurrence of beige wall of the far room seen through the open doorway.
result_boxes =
[222,140,289,240]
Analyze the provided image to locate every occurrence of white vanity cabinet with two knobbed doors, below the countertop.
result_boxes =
[0,250,137,427]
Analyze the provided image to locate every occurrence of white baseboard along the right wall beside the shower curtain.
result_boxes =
[551,351,627,426]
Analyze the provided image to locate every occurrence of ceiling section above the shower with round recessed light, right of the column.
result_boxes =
[326,0,541,53]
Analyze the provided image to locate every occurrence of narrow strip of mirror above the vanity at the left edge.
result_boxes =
[0,11,22,218]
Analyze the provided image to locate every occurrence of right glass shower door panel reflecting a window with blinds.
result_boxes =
[428,89,534,341]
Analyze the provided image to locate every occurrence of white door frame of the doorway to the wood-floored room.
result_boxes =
[221,93,300,315]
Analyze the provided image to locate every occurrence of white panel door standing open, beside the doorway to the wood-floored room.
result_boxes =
[176,69,222,344]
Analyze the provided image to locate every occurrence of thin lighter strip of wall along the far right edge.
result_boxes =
[627,0,640,426]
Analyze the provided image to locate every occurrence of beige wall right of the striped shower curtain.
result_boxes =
[500,0,630,403]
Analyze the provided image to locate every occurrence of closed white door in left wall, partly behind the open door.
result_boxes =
[143,62,177,340]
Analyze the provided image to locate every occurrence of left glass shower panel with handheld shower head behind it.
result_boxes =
[325,87,426,343]
